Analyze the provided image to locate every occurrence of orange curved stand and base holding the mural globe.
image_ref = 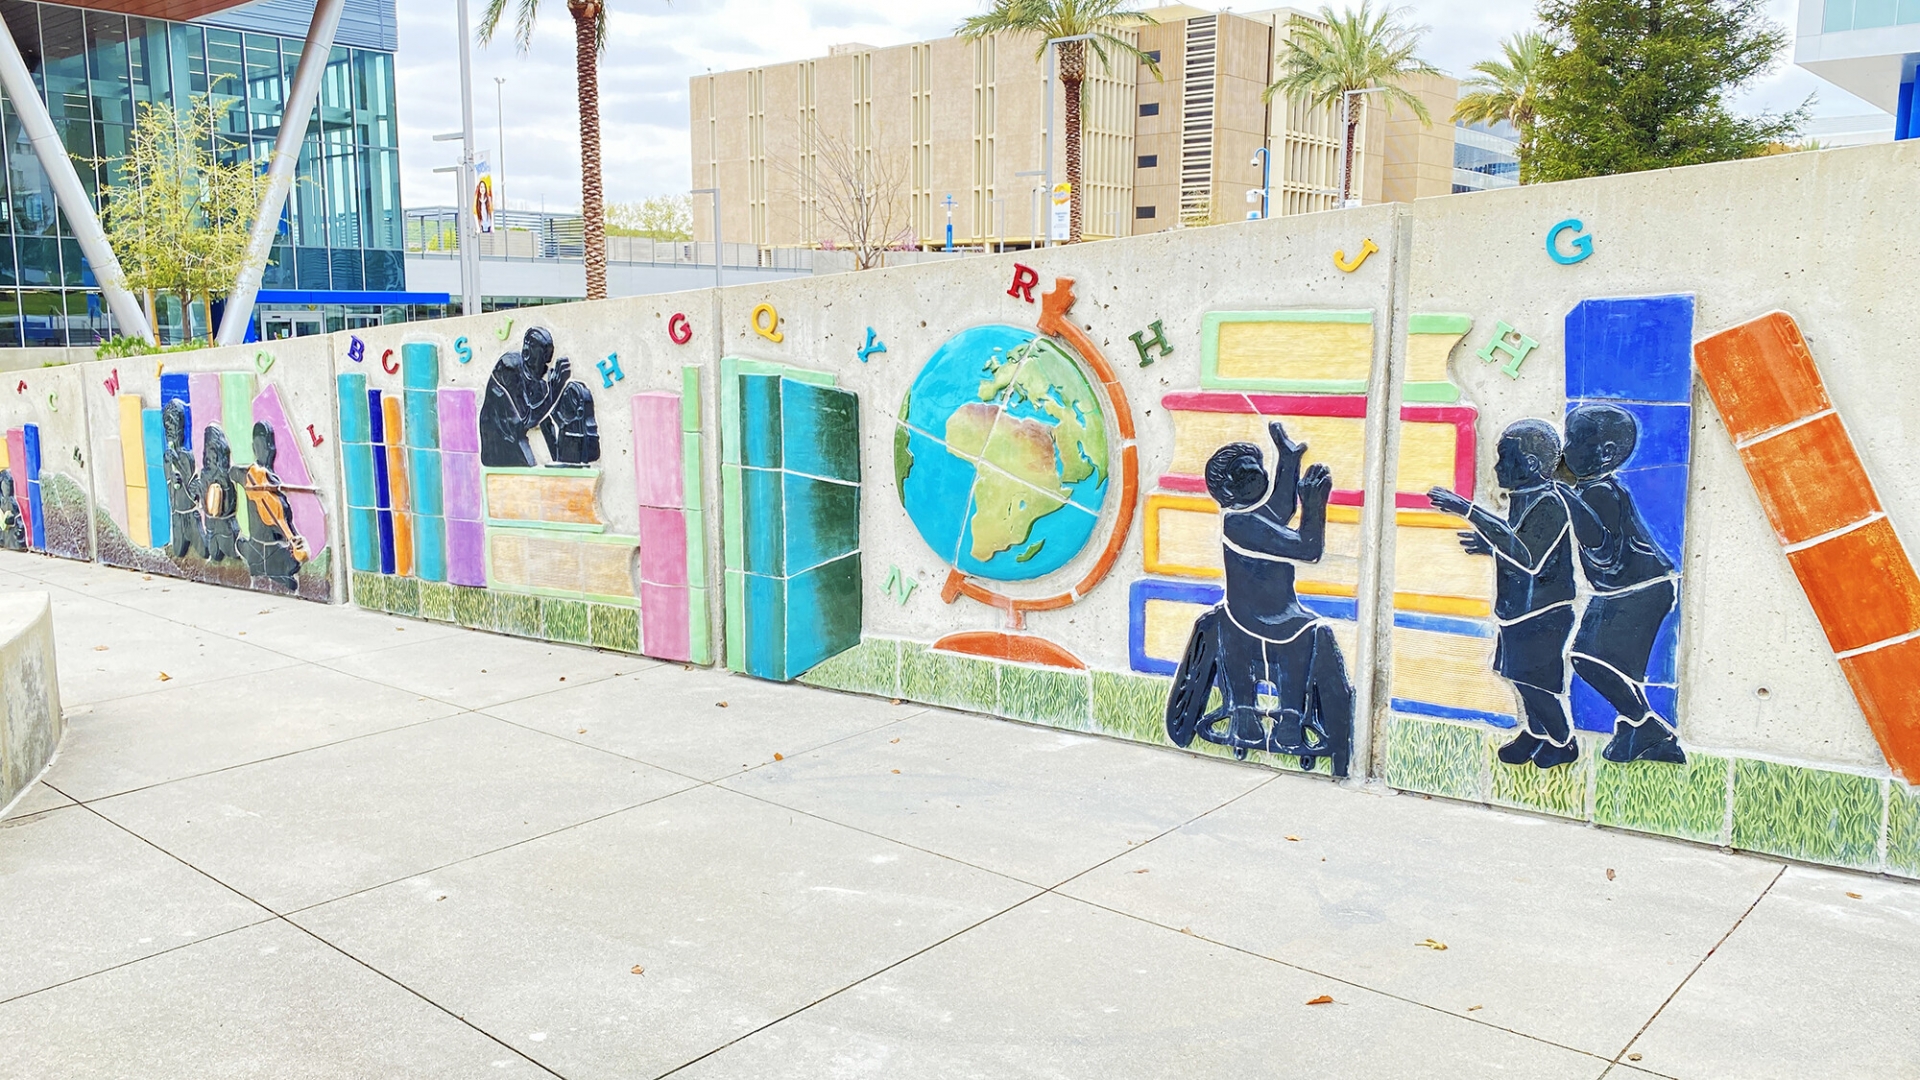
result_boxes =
[933,277,1140,671]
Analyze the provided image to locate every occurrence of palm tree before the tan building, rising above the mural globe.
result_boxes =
[956,0,1160,244]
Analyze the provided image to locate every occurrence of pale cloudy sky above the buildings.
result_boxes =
[397,0,1874,209]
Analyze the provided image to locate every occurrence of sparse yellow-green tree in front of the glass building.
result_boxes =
[100,94,267,338]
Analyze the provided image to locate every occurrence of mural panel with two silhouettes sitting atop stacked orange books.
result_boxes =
[336,315,710,663]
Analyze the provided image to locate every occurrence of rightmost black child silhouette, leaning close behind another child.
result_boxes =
[1567,405,1686,763]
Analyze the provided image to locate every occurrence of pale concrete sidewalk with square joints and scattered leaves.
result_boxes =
[0,555,1920,1080]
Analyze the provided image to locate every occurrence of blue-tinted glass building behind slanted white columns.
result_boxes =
[0,0,405,346]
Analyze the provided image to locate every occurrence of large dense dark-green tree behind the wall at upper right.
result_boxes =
[1534,0,1812,181]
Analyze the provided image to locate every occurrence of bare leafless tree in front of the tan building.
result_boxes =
[768,131,912,269]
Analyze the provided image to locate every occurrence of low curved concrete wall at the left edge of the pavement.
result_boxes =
[0,592,65,813]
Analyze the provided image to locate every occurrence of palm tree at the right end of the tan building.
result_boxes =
[1263,0,1440,206]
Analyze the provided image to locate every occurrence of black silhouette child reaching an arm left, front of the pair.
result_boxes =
[1427,419,1580,769]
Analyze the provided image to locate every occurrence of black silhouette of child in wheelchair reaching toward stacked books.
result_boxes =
[1167,421,1354,776]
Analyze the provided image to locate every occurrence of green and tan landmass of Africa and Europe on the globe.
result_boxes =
[947,338,1106,561]
